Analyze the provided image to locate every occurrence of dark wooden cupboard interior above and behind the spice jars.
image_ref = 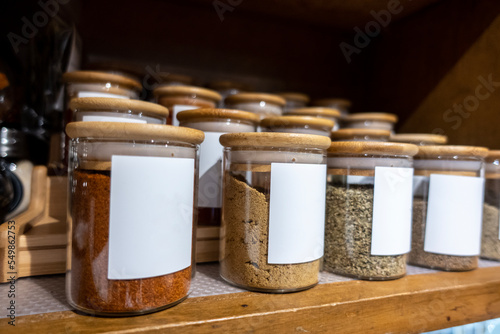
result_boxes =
[73,0,500,148]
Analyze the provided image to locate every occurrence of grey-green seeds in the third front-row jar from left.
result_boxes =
[323,184,406,280]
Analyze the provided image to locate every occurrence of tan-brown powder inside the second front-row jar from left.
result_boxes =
[221,173,320,292]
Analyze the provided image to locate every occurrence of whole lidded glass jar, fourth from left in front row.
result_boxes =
[409,145,488,271]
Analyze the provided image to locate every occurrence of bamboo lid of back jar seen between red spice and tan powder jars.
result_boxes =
[177,108,260,124]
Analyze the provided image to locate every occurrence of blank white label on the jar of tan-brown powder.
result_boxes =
[268,163,326,264]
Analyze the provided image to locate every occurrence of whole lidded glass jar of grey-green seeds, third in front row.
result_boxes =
[323,141,418,280]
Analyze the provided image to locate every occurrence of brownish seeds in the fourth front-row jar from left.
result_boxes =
[408,198,478,271]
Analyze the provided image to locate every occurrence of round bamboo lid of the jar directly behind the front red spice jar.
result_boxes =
[69,97,168,118]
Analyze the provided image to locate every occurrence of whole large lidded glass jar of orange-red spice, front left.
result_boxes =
[66,122,204,316]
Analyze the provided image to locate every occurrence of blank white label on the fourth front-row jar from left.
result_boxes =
[424,174,484,256]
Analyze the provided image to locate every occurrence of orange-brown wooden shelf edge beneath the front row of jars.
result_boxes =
[4,266,500,333]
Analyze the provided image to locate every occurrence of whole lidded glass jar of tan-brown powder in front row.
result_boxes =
[220,132,330,293]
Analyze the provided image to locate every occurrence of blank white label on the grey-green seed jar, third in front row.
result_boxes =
[371,167,413,256]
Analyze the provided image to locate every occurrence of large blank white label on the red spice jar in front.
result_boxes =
[108,155,194,280]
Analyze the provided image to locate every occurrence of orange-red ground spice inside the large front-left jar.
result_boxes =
[69,169,191,315]
